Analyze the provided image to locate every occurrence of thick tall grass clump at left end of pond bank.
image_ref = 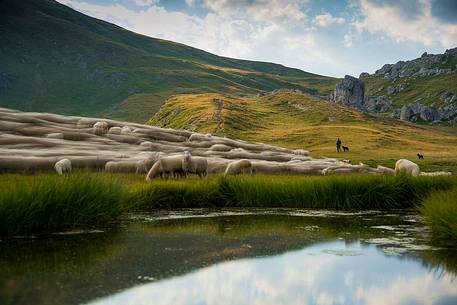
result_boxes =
[0,172,128,235]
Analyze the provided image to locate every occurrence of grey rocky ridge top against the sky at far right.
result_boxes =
[374,48,457,79]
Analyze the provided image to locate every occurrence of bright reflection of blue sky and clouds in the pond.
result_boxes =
[88,241,457,305]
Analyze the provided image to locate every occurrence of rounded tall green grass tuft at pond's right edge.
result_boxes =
[419,187,457,242]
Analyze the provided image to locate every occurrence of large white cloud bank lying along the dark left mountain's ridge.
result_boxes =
[56,0,334,75]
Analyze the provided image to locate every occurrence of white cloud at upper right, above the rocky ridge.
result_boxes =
[353,0,457,47]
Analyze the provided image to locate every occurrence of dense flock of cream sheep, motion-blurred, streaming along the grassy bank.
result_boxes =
[0,108,449,180]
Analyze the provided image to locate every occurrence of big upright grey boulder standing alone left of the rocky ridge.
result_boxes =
[333,75,365,109]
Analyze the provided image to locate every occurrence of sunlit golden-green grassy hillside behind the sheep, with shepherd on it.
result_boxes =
[149,90,457,171]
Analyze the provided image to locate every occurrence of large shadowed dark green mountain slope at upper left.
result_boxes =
[0,0,336,122]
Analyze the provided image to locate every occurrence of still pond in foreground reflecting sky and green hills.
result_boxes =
[0,209,457,305]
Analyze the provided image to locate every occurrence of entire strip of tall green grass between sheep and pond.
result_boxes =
[0,172,457,236]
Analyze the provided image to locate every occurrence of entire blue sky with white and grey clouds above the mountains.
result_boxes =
[58,0,457,77]
